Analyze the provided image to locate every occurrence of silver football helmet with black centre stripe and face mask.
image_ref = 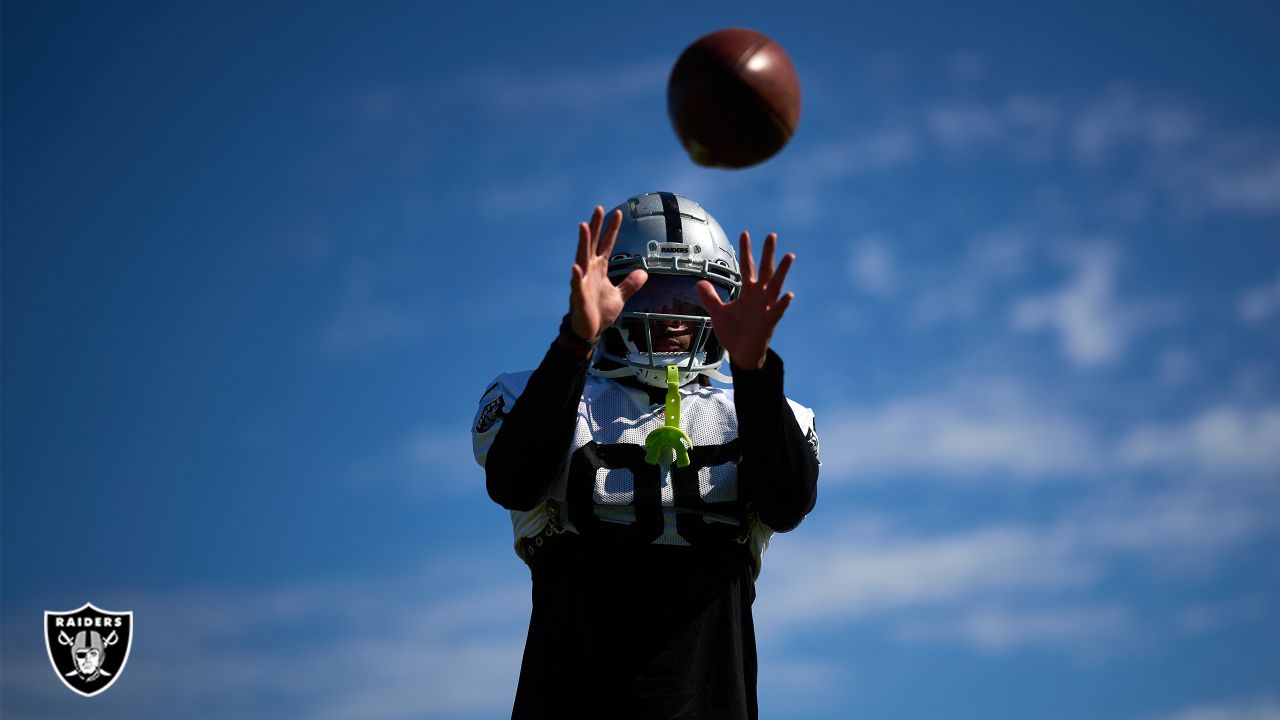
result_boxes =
[593,192,742,388]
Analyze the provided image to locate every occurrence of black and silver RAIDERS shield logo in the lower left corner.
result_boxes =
[45,602,133,697]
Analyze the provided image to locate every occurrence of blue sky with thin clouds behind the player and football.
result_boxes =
[0,1,1280,720]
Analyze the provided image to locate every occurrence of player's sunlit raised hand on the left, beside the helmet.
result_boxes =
[568,205,649,340]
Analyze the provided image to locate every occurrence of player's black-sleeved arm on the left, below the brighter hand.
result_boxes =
[485,333,589,510]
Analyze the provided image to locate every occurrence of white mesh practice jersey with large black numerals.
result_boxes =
[471,372,817,571]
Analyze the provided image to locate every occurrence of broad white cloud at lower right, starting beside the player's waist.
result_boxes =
[758,471,1280,652]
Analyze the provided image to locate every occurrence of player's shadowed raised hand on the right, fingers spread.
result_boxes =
[698,232,796,370]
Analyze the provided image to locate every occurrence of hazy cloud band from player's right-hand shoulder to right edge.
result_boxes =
[819,363,1280,482]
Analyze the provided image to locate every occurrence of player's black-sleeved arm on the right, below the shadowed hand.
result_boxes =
[733,350,818,532]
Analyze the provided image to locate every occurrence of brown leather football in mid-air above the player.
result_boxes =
[667,28,800,168]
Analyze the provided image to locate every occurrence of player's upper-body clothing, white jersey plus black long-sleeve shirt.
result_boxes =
[474,343,818,719]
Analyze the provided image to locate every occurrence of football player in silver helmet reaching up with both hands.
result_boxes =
[472,192,818,719]
